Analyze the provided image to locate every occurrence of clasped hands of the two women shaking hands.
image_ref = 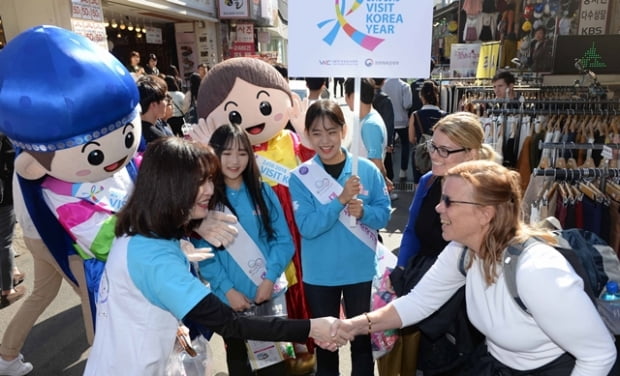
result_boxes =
[309,317,364,351]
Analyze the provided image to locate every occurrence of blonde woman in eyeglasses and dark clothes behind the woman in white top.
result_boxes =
[381,112,496,375]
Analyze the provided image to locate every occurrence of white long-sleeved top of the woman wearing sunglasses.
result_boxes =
[394,242,616,376]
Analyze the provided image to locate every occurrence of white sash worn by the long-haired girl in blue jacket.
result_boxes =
[224,207,288,296]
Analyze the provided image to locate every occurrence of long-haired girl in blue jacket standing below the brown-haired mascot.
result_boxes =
[200,125,294,376]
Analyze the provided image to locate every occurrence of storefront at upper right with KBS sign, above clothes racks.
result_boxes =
[433,0,620,83]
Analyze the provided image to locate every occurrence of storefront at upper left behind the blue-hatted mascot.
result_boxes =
[0,0,222,83]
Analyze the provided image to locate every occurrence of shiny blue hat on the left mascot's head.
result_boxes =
[0,25,140,152]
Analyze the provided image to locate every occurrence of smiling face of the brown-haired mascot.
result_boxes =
[210,78,291,145]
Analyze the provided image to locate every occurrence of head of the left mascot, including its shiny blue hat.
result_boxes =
[0,25,142,183]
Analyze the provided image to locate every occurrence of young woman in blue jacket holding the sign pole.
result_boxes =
[289,100,391,376]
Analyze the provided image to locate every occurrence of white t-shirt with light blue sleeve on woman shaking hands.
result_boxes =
[84,235,210,376]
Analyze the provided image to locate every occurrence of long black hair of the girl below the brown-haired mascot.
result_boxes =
[209,124,276,240]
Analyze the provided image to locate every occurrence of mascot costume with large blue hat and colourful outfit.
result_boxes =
[0,26,141,347]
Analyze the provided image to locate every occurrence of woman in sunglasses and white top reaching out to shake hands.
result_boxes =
[344,160,617,376]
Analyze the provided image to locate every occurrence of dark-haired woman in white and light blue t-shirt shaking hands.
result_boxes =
[85,137,344,375]
